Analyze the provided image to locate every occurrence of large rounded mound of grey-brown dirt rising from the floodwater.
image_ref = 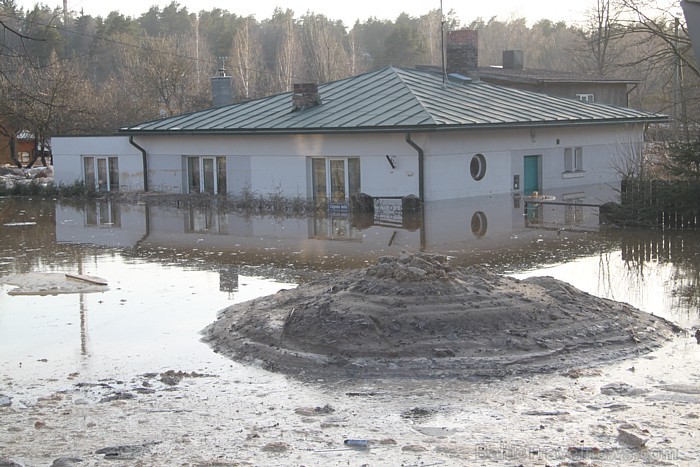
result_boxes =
[204,252,679,378]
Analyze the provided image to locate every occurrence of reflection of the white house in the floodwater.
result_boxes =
[56,185,612,266]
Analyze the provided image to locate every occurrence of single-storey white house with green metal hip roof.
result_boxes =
[52,67,667,203]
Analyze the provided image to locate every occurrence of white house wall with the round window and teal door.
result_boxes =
[424,125,643,201]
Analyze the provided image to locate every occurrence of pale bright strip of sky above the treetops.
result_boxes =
[17,0,596,26]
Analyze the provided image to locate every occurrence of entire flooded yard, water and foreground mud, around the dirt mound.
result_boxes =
[0,198,700,466]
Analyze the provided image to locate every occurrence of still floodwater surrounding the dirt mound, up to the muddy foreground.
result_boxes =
[0,198,700,464]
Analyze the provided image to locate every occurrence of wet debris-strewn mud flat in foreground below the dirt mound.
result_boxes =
[0,337,700,467]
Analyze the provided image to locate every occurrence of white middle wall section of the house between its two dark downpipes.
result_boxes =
[135,134,418,198]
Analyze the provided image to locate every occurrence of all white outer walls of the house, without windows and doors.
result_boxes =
[53,121,642,201]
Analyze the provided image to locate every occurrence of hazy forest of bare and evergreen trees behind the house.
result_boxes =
[0,0,700,167]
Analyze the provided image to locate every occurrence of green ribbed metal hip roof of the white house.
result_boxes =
[119,67,667,134]
